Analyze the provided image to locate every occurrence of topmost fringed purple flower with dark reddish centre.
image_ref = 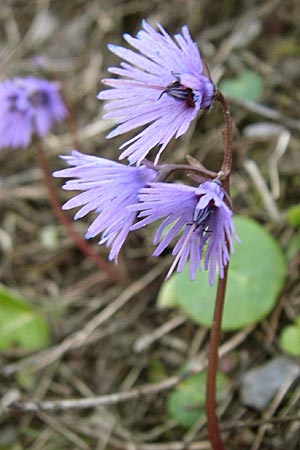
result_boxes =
[98,21,215,163]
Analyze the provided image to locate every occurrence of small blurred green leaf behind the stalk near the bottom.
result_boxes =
[167,372,228,428]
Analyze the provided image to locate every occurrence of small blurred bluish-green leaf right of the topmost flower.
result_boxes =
[219,70,264,101]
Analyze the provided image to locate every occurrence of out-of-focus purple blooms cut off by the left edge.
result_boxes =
[0,77,67,148]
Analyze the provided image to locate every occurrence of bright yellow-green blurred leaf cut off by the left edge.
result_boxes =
[0,285,49,350]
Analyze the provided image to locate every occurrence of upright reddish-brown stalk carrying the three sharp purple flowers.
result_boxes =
[205,91,232,450]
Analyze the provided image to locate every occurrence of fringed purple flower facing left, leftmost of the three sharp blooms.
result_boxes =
[53,150,156,262]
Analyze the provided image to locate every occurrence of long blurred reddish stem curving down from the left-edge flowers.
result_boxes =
[35,137,120,283]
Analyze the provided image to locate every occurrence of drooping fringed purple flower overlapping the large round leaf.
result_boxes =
[130,181,238,285]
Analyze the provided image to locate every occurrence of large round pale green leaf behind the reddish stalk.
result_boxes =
[157,217,286,330]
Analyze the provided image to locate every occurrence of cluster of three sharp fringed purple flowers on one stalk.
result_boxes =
[54,22,238,284]
